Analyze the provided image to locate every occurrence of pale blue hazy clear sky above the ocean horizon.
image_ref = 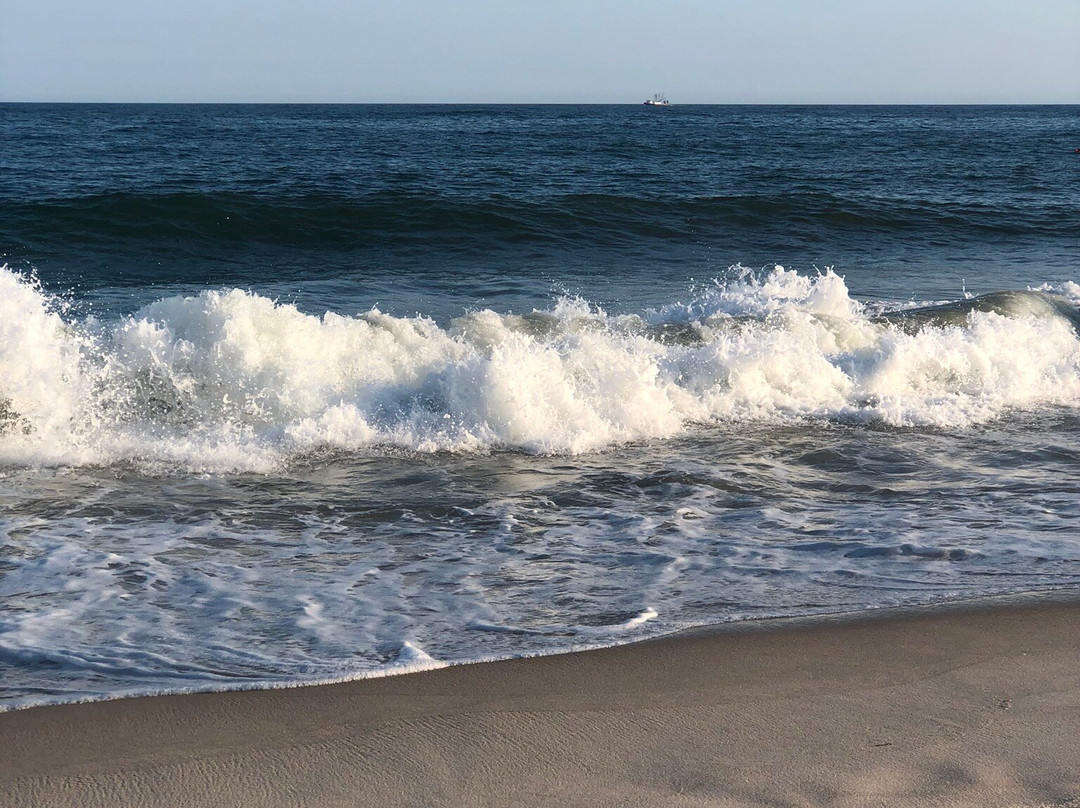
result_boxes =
[6,0,1080,104]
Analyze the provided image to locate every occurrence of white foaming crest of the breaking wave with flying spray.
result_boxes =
[0,267,1080,471]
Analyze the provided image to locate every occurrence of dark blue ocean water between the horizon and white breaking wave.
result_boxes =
[6,105,1080,314]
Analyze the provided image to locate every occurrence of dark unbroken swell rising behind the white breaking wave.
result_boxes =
[0,191,1076,248]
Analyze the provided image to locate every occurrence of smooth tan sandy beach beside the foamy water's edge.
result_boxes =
[0,601,1080,808]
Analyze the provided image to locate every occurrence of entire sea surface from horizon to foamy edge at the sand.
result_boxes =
[0,104,1080,709]
